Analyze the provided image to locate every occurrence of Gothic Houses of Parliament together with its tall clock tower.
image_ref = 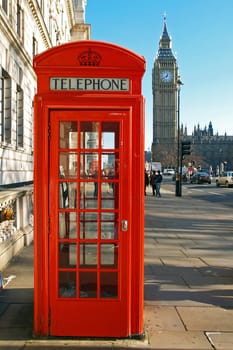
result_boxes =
[149,18,233,171]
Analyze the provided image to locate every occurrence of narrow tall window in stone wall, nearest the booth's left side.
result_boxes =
[16,85,24,147]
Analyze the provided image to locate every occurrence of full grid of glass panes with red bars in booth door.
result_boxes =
[58,121,120,299]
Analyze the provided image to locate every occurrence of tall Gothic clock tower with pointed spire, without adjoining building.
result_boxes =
[152,17,178,166]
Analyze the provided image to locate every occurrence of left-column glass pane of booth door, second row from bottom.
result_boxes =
[58,242,77,267]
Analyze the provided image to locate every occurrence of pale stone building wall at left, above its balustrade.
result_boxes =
[0,0,90,186]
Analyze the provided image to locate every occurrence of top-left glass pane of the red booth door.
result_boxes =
[60,122,78,148]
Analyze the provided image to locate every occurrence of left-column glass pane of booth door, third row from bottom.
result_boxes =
[59,212,77,238]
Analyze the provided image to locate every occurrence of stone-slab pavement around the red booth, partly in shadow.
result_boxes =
[0,183,233,350]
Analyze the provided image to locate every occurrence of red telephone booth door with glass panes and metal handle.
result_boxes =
[48,109,131,337]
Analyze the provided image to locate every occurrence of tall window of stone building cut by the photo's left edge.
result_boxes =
[0,69,11,143]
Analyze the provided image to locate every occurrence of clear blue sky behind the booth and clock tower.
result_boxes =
[86,0,233,149]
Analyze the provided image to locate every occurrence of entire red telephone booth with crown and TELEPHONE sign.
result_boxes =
[34,41,145,337]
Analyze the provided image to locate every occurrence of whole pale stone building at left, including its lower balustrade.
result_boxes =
[0,0,90,270]
